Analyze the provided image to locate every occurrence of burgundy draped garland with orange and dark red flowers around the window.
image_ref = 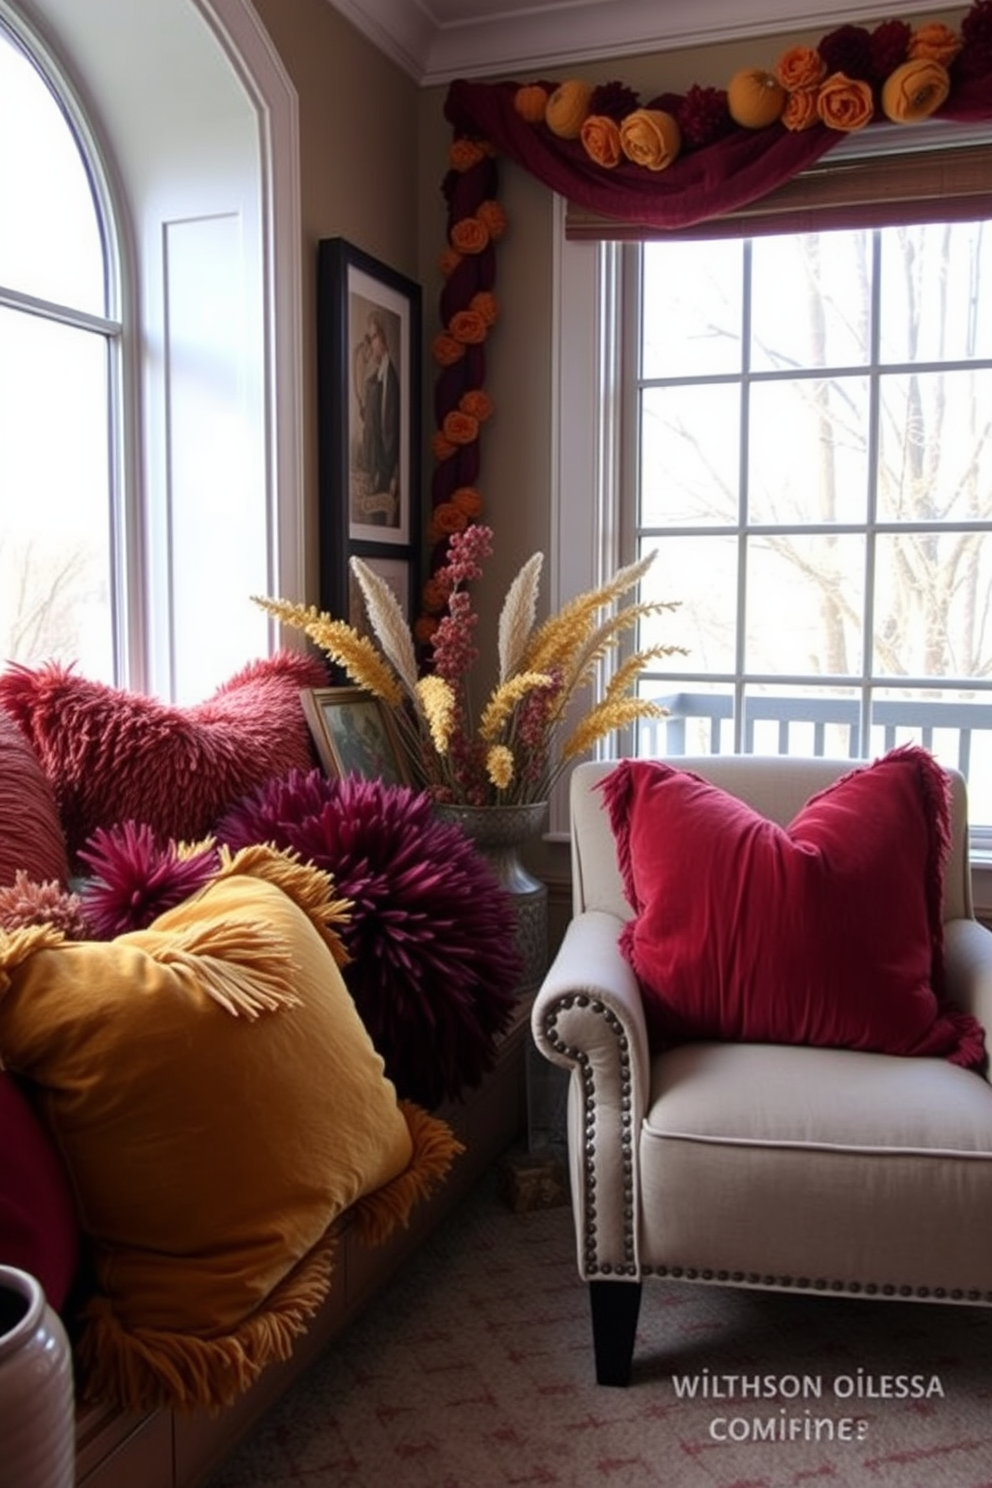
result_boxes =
[415,0,992,646]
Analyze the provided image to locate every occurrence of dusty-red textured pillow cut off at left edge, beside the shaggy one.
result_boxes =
[0,711,68,884]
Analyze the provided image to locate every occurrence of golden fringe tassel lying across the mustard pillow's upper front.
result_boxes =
[149,923,300,1021]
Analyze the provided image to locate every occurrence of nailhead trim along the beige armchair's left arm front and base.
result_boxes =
[543,992,992,1306]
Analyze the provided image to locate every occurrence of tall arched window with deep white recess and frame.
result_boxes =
[0,0,303,702]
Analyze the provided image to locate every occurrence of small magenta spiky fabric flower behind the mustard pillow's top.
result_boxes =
[79,821,217,940]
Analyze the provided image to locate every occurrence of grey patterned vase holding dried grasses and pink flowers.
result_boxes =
[434,801,547,995]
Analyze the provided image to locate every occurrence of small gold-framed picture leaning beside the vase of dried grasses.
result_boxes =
[300,687,409,786]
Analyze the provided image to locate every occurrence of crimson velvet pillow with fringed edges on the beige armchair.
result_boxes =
[602,745,985,1065]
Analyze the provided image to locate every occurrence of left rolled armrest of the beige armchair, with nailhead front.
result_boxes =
[531,911,650,1280]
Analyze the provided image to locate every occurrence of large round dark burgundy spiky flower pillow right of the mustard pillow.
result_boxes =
[216,771,521,1109]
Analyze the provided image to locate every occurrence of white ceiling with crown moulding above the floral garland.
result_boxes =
[330,0,956,86]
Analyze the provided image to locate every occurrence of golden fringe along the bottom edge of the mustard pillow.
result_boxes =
[74,1232,336,1414]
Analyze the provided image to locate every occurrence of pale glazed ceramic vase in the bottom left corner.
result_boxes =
[0,1266,76,1488]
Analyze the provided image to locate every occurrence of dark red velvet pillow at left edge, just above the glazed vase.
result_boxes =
[0,1070,80,1312]
